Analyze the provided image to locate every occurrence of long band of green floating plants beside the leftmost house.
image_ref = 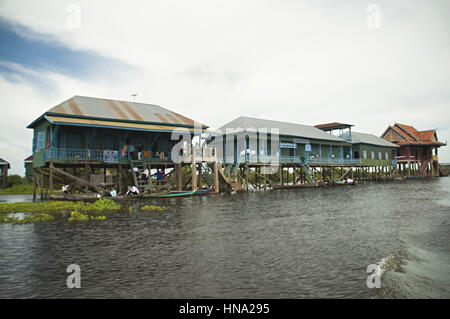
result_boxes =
[0,199,121,213]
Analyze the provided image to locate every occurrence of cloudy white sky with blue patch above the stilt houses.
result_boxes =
[0,0,450,175]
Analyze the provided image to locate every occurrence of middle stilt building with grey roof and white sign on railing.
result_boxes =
[213,116,355,165]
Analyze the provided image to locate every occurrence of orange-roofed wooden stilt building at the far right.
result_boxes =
[381,123,447,176]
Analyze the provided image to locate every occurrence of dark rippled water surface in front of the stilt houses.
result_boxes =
[0,178,450,298]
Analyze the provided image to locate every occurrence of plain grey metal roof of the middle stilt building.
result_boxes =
[219,116,348,143]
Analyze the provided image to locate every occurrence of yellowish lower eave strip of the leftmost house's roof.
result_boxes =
[46,115,214,133]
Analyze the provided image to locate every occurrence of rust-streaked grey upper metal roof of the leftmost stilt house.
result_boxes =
[46,95,207,128]
